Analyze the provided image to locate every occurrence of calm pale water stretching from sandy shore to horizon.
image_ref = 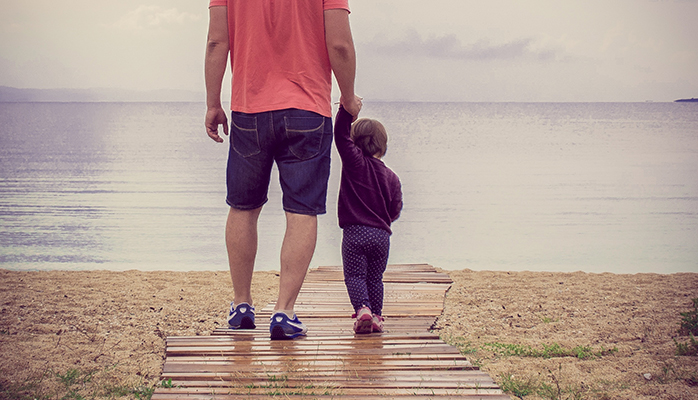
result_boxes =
[0,103,698,273]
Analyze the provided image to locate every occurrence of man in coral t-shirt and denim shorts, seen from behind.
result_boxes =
[205,0,361,339]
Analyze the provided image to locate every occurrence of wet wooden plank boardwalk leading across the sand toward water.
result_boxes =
[152,264,510,400]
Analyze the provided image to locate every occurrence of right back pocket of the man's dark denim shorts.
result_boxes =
[284,116,325,160]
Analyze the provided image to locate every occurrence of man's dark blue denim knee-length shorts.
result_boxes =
[226,109,332,215]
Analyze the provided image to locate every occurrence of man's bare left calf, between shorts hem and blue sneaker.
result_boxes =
[225,207,262,305]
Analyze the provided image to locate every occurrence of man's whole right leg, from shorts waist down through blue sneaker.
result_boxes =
[269,109,332,339]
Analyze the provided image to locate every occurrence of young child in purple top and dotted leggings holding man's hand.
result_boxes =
[334,106,402,333]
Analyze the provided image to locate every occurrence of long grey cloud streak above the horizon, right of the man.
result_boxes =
[364,29,559,61]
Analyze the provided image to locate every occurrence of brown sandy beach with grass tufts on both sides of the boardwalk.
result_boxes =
[0,270,698,399]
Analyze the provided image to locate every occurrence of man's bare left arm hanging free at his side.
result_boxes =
[204,6,230,143]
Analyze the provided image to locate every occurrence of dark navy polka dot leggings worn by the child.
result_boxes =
[342,225,390,315]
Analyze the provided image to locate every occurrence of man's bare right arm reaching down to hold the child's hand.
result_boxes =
[325,9,361,119]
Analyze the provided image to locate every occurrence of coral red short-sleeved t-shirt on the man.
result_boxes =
[209,0,349,117]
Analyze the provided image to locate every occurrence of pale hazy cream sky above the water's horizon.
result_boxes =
[0,0,698,102]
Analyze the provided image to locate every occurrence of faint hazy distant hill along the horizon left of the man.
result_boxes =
[0,86,205,103]
